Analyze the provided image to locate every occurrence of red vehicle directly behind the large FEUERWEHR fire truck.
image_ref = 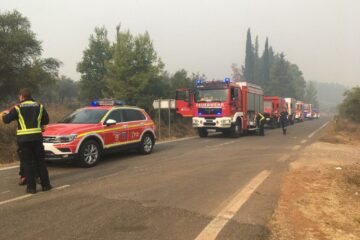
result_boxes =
[264,96,286,128]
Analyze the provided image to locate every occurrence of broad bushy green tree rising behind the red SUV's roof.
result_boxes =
[106,29,164,107]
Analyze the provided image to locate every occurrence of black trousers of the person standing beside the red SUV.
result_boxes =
[18,140,50,189]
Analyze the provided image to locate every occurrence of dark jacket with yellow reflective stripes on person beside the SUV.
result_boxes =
[3,99,49,142]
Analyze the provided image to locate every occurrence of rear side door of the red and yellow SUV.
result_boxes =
[122,108,146,143]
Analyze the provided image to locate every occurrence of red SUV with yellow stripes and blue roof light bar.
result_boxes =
[43,99,156,167]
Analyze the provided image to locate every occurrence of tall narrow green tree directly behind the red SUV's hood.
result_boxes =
[77,27,112,100]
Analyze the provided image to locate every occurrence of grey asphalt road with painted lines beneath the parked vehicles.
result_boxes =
[0,119,327,240]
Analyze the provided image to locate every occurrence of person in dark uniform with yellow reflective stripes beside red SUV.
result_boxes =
[1,88,52,193]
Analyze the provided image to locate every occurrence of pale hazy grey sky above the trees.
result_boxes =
[0,0,360,85]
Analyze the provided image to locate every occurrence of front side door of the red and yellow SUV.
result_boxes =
[104,109,128,148]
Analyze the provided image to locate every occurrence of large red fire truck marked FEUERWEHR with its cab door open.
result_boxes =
[176,78,264,137]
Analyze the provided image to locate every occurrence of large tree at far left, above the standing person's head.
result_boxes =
[0,11,50,98]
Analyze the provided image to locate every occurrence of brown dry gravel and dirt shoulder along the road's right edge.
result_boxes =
[269,122,360,240]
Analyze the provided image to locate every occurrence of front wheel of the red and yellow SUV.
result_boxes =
[78,140,101,168]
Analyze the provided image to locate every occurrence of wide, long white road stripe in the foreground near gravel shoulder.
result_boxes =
[195,170,271,240]
